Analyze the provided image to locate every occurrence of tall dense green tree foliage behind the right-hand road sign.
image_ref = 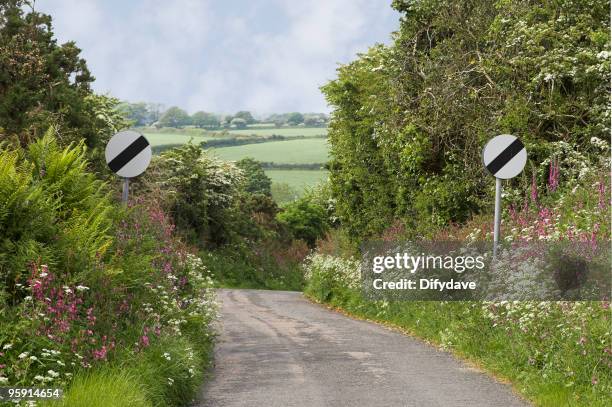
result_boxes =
[322,0,610,241]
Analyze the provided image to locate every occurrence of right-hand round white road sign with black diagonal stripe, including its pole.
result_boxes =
[482,134,527,257]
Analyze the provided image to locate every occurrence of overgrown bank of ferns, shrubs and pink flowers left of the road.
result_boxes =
[0,1,316,407]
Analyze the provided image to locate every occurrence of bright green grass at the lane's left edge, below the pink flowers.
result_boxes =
[38,335,213,407]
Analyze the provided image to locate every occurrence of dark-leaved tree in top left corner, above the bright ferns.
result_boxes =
[0,0,97,147]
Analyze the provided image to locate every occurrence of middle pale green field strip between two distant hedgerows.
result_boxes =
[212,138,329,164]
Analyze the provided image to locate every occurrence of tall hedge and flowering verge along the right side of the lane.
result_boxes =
[296,0,612,407]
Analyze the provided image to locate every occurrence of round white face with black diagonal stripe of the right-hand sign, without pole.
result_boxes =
[482,134,527,179]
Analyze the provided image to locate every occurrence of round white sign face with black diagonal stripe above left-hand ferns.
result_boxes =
[104,130,153,178]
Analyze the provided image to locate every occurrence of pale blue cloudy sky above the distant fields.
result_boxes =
[35,0,399,114]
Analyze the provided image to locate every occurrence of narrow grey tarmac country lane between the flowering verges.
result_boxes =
[199,290,526,407]
